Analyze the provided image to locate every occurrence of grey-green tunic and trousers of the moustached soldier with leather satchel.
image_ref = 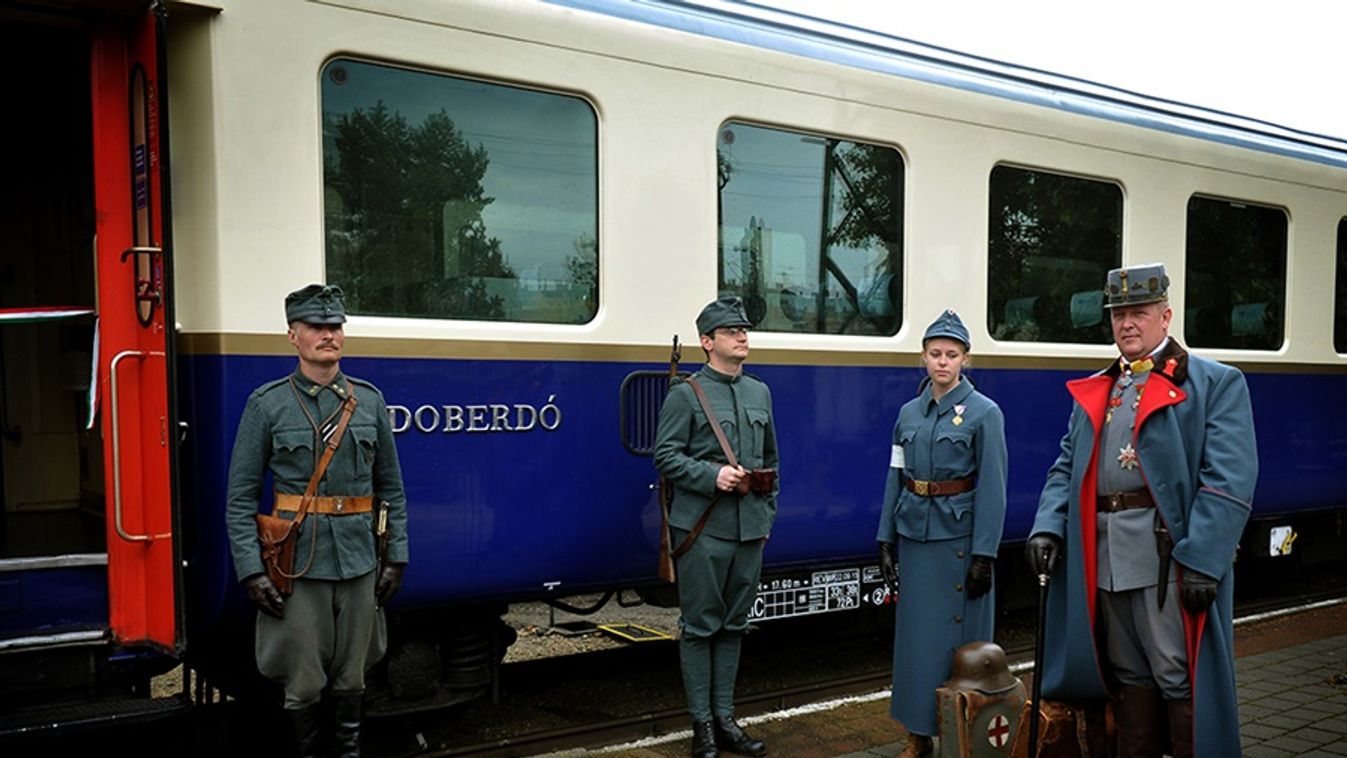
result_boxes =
[225,370,408,708]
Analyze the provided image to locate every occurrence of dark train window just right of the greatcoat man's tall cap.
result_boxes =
[1183,195,1286,350]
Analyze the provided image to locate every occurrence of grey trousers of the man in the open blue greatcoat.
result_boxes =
[1098,576,1192,700]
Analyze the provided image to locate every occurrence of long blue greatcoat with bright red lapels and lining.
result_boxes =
[1032,339,1258,755]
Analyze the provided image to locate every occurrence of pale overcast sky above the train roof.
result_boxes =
[756,0,1347,140]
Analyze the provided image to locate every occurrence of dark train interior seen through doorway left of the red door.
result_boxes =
[0,16,106,559]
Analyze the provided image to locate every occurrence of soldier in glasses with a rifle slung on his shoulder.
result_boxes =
[655,298,777,758]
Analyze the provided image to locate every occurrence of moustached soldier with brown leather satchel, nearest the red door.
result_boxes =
[225,284,407,757]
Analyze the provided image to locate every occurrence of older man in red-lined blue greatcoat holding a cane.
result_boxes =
[1026,264,1258,758]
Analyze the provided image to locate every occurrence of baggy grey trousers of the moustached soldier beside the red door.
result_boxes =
[255,571,388,710]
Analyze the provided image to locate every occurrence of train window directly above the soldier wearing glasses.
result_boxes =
[715,121,902,335]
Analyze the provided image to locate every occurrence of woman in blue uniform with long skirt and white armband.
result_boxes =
[877,311,1006,758]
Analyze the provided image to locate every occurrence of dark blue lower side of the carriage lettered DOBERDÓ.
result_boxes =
[180,355,1347,630]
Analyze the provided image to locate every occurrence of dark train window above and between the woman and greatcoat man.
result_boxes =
[987,166,1122,343]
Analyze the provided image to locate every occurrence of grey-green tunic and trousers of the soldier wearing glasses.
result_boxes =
[655,366,780,722]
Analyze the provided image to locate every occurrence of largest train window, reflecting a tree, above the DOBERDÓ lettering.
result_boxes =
[322,59,598,323]
